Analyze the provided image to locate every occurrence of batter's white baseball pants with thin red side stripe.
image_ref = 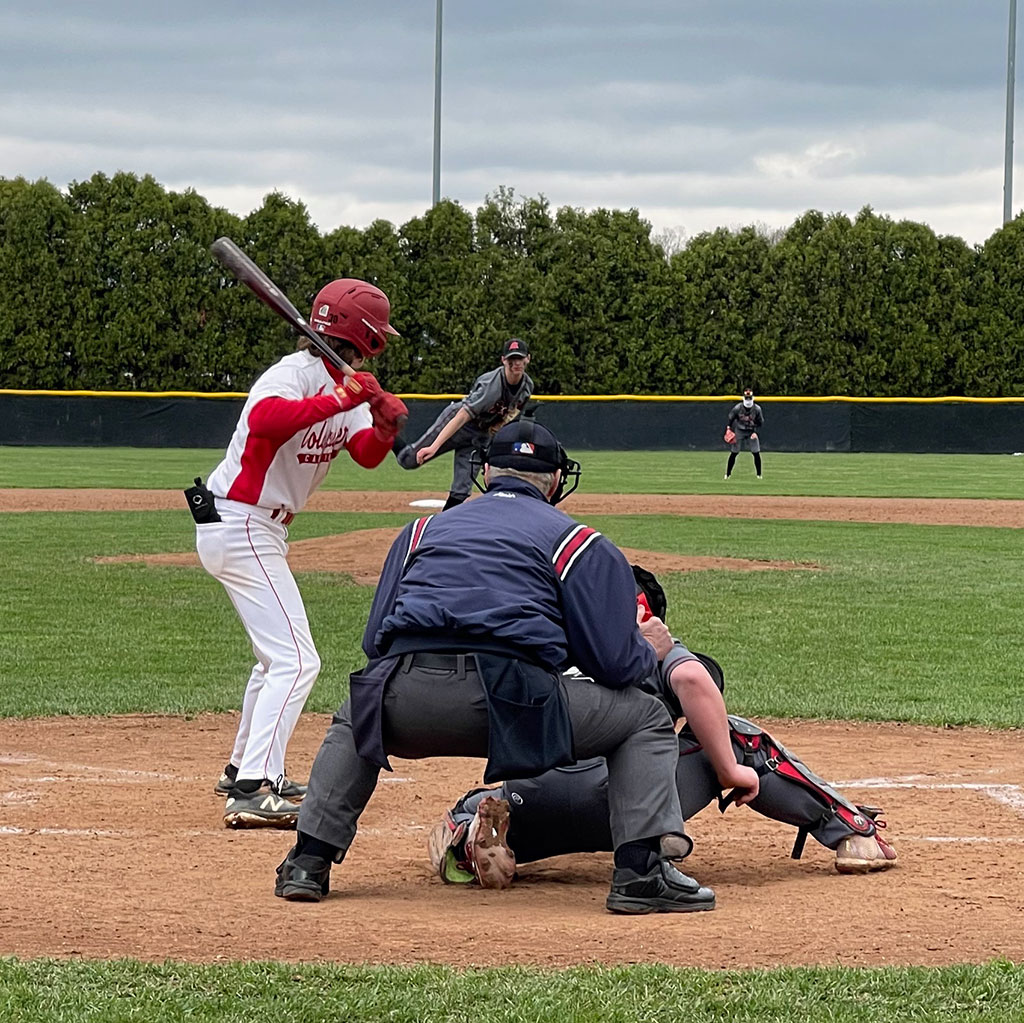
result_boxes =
[196,501,321,781]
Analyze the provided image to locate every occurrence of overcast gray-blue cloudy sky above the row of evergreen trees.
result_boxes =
[0,0,1024,244]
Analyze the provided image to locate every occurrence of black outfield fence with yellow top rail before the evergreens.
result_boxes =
[0,390,1024,455]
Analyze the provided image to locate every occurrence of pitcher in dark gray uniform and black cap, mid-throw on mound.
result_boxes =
[395,338,534,511]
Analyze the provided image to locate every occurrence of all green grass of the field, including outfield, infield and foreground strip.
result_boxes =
[0,447,1024,1023]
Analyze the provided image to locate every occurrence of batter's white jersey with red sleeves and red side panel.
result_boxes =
[207,351,376,514]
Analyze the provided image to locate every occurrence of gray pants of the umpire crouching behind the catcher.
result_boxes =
[298,653,683,862]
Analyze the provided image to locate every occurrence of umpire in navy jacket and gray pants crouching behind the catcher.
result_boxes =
[274,420,715,913]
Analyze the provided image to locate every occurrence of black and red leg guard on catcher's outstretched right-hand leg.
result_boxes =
[720,715,882,859]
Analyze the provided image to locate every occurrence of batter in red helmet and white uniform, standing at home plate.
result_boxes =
[185,279,408,827]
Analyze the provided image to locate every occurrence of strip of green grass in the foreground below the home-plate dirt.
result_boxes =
[0,960,1024,1023]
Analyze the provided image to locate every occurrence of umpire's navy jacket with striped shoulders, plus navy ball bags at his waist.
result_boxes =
[351,476,657,779]
